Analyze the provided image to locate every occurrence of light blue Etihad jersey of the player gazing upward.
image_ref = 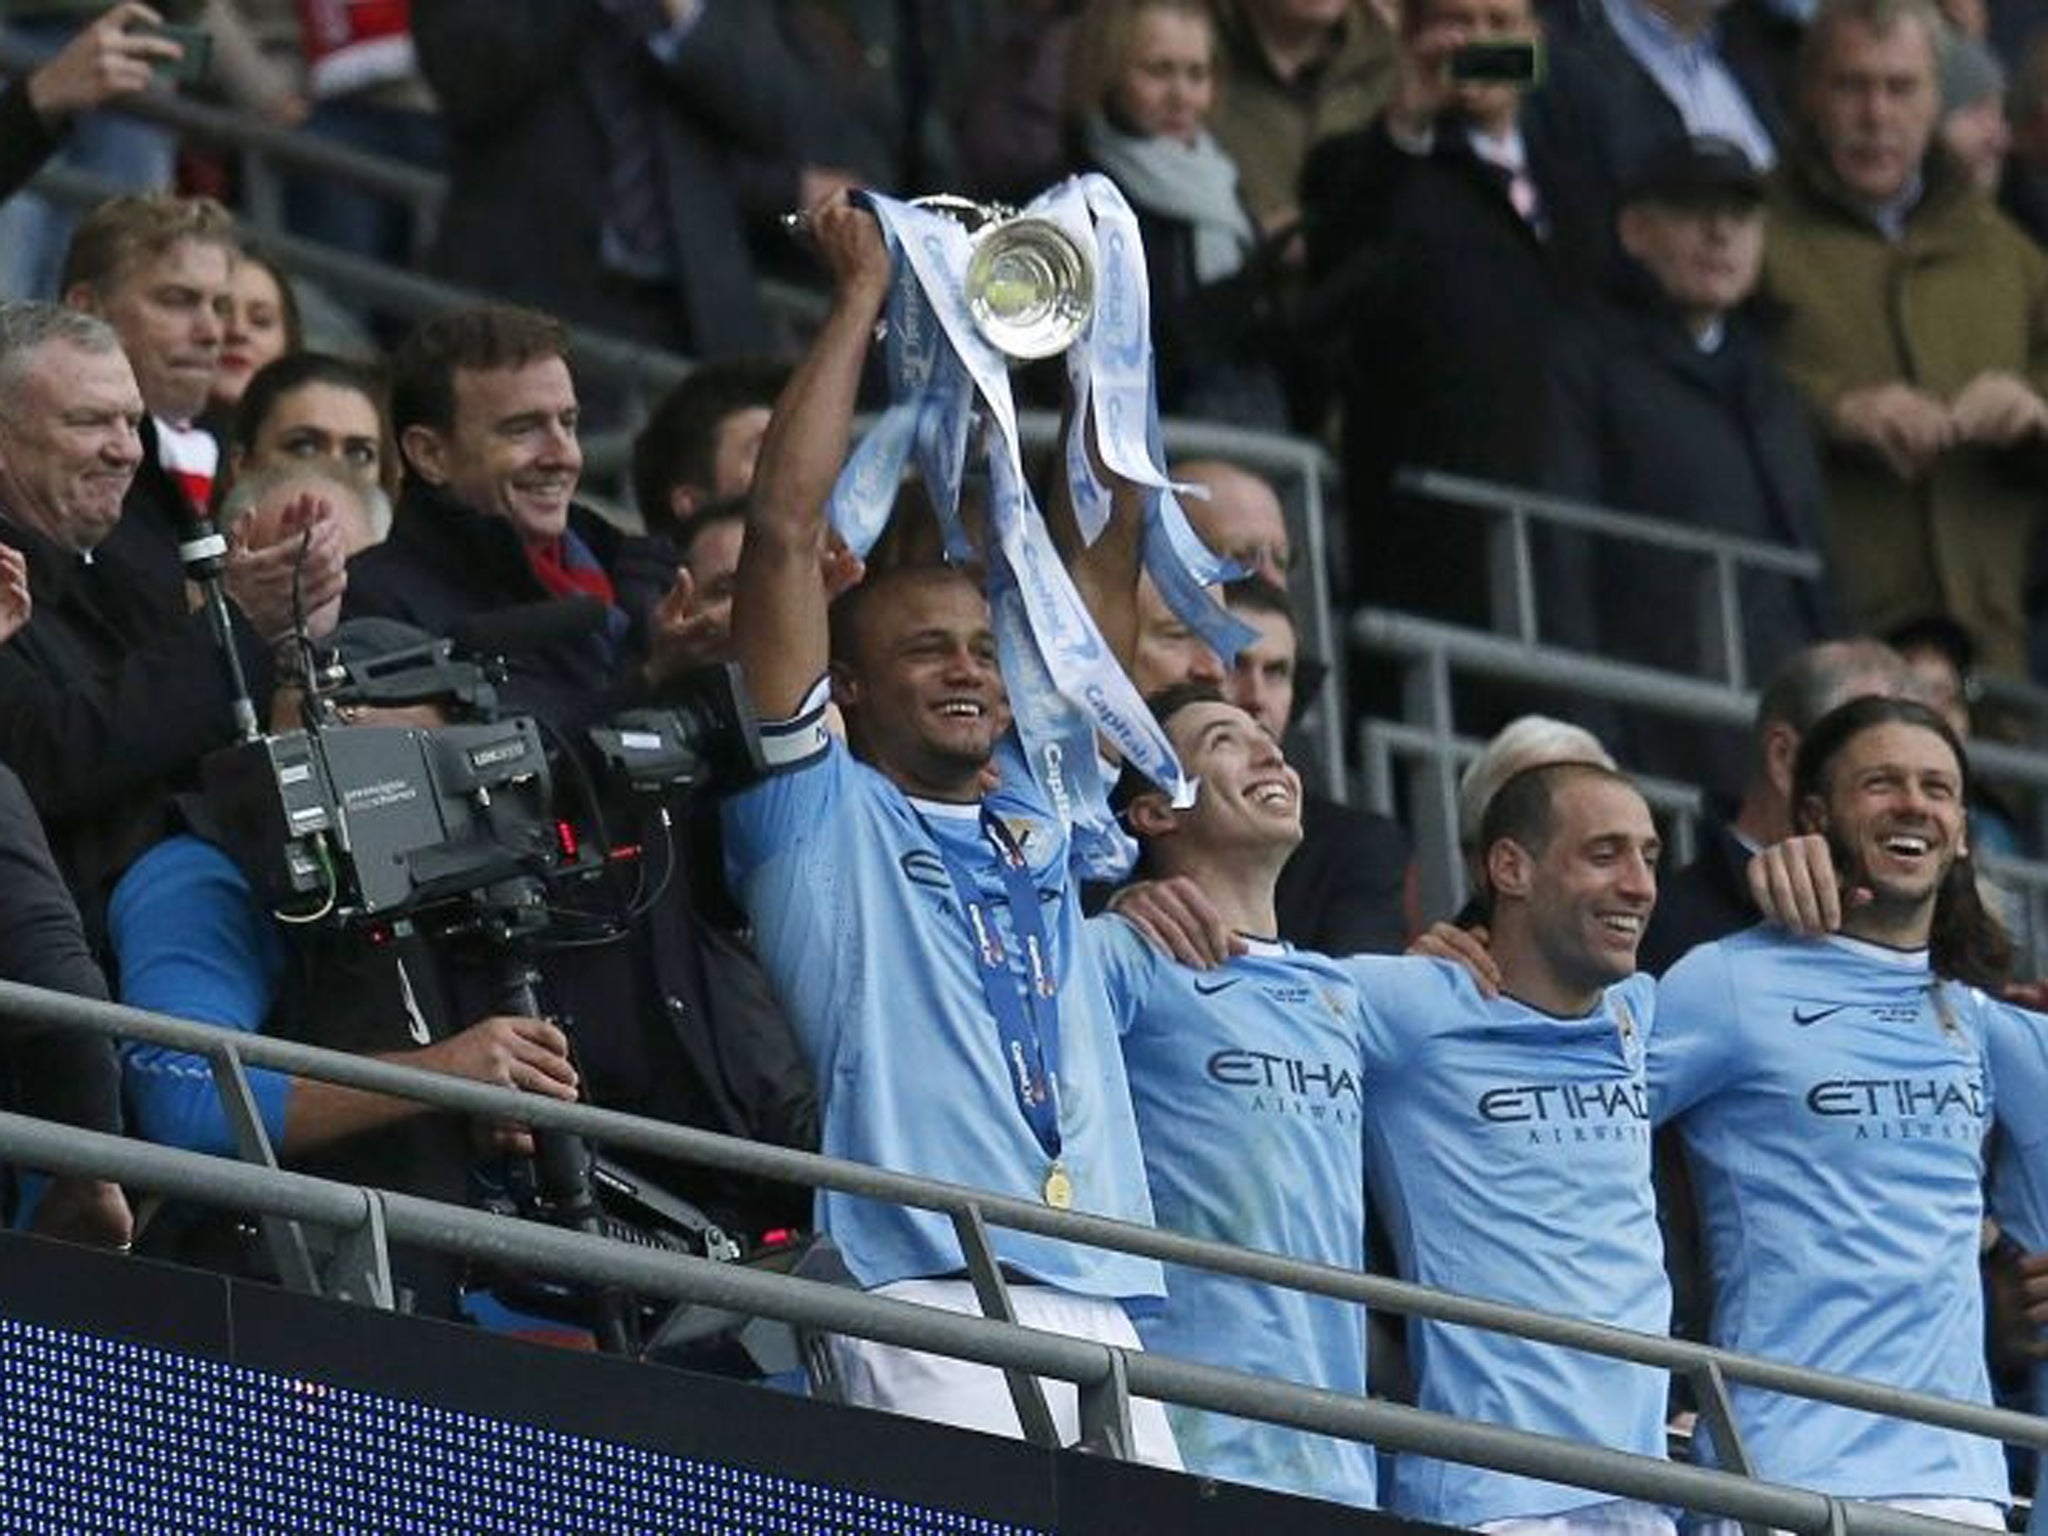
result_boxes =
[1090,918,1374,1507]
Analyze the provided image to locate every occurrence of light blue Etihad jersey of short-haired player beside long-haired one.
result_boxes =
[1343,956,1671,1526]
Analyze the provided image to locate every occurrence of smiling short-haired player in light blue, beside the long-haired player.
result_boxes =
[1346,764,1671,1536]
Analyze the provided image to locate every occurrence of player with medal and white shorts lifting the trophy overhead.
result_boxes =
[725,201,1178,1464]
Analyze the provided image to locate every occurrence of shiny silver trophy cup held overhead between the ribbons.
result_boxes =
[782,193,1096,362]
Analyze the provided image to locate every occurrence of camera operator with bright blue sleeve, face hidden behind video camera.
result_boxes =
[109,614,578,1315]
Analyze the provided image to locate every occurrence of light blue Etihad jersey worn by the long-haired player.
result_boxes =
[1651,928,2007,1503]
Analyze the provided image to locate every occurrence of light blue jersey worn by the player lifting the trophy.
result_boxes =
[723,737,1163,1303]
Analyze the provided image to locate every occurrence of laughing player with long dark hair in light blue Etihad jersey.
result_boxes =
[1651,696,2009,1528]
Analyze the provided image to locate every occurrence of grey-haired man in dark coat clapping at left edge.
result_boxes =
[0,303,344,934]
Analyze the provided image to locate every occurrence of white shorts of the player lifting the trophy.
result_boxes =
[813,1280,1182,1473]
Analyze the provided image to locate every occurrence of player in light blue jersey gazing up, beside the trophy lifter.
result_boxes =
[1090,682,1374,1507]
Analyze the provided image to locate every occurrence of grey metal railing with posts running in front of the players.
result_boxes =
[0,983,2048,1536]
